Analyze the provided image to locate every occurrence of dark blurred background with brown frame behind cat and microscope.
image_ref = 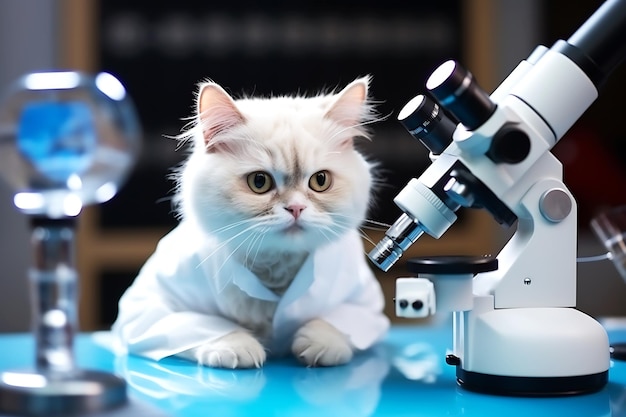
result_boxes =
[0,0,626,332]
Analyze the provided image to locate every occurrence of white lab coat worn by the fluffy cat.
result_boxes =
[112,221,389,360]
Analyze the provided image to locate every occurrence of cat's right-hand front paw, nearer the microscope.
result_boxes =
[291,319,352,366]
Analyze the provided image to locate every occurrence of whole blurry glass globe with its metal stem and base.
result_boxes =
[0,71,141,416]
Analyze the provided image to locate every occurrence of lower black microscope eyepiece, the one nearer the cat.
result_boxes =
[398,94,456,155]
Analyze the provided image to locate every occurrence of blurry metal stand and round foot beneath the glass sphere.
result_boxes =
[0,218,127,416]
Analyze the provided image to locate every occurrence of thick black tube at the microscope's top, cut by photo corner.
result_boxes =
[555,0,626,87]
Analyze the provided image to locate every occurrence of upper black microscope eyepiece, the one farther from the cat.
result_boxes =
[426,60,496,130]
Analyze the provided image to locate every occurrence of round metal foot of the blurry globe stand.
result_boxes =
[0,370,127,416]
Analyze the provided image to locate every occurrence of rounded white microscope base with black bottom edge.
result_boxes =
[449,296,610,396]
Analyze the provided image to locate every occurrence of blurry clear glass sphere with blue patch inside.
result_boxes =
[0,72,141,218]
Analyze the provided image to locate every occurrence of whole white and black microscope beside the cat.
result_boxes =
[368,0,626,396]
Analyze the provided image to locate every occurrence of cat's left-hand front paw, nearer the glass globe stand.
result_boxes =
[181,331,266,369]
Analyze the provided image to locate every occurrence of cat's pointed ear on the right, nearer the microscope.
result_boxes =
[326,76,370,127]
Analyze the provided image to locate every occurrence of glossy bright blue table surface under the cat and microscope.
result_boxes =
[0,323,626,417]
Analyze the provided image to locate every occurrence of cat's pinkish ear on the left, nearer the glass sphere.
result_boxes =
[197,82,244,149]
